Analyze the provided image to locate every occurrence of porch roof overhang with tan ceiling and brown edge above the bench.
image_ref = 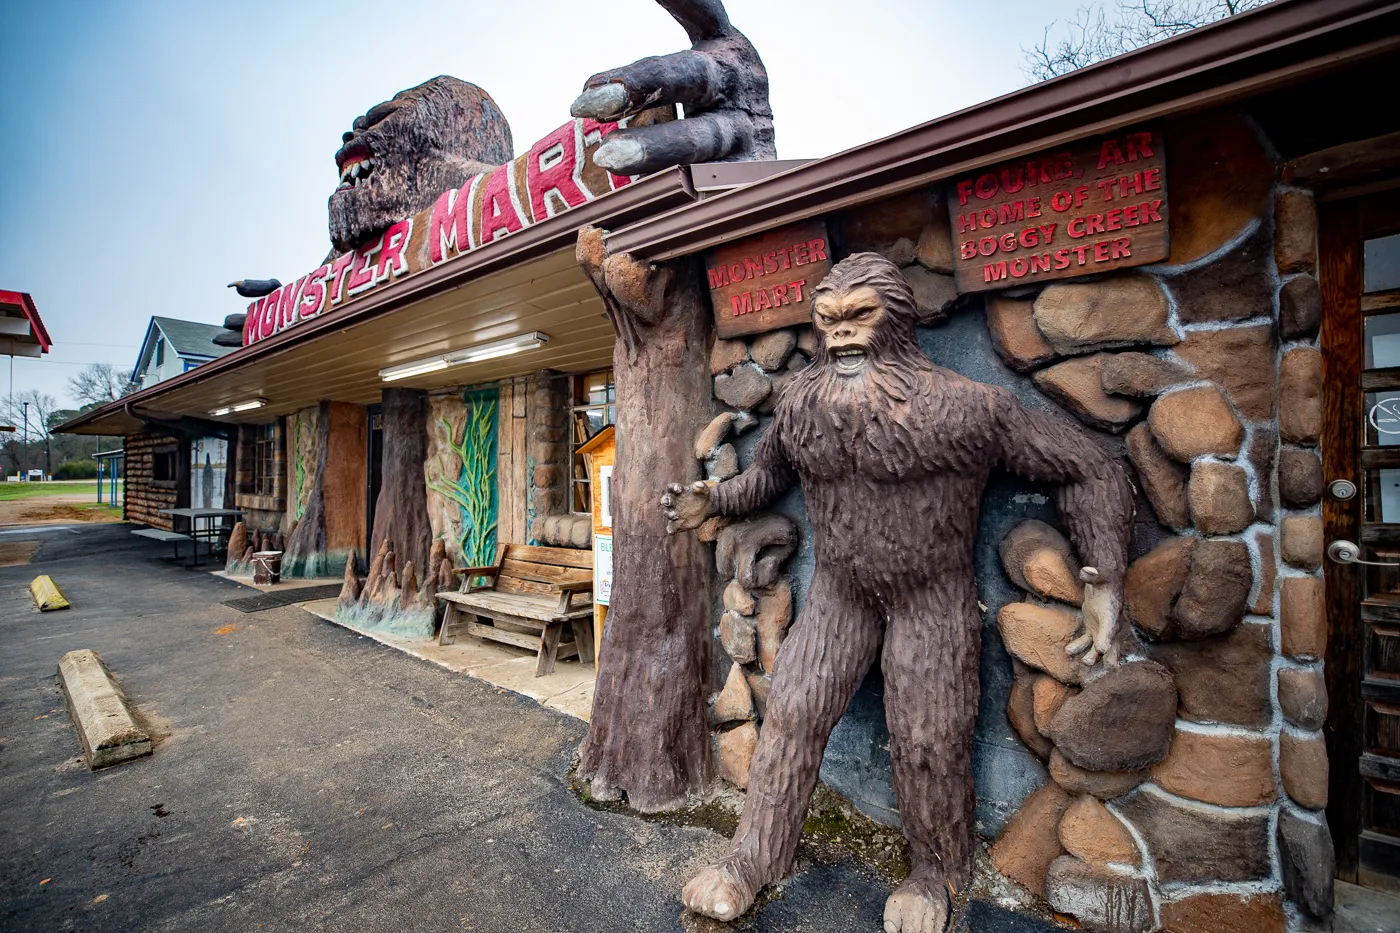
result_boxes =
[56,168,694,434]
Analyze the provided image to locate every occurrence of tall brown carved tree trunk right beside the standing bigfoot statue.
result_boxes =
[578,227,714,813]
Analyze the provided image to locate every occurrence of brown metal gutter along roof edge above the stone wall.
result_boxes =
[608,0,1400,261]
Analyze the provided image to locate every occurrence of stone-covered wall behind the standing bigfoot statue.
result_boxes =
[694,105,1333,933]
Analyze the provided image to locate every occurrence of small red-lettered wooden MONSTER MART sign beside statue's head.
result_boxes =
[706,220,832,339]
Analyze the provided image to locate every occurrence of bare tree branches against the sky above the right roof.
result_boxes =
[1021,0,1268,84]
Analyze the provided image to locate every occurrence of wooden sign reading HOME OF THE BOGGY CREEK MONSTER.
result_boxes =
[948,127,1169,291]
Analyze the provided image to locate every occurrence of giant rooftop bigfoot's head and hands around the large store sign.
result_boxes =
[216,0,777,346]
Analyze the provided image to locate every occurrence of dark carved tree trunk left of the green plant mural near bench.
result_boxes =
[370,388,433,569]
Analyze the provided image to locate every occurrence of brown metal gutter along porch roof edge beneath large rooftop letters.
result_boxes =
[53,168,696,433]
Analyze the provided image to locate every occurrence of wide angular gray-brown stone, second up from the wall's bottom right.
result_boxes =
[1113,786,1273,884]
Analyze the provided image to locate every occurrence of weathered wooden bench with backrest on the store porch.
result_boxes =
[437,545,594,677]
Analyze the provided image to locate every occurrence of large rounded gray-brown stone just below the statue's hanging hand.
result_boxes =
[1050,661,1176,770]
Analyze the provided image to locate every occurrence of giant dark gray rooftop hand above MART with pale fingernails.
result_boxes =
[570,0,777,175]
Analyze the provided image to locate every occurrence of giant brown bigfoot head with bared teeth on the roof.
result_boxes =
[329,76,514,252]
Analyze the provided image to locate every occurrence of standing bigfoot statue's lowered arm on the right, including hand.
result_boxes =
[993,389,1133,665]
